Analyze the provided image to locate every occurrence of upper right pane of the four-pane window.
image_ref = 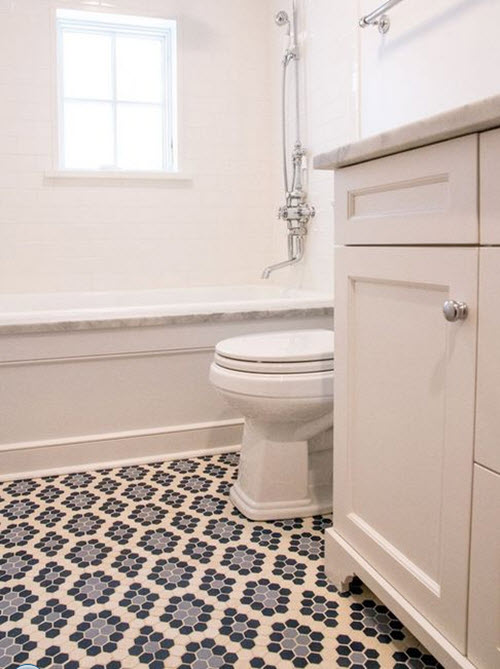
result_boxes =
[116,35,163,103]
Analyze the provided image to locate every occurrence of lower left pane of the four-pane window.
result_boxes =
[64,102,114,169]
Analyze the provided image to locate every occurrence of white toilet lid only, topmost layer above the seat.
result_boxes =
[215,330,334,364]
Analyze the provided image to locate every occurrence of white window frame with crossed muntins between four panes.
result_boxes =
[56,9,178,174]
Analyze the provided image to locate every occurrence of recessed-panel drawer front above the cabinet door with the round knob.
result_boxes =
[335,135,479,245]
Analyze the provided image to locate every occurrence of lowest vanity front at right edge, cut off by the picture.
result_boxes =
[468,465,500,669]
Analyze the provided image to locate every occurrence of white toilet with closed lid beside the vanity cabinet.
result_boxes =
[210,330,334,520]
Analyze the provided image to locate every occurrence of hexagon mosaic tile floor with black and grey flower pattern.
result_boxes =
[0,454,440,669]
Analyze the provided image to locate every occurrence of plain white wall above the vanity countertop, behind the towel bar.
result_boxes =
[296,0,500,144]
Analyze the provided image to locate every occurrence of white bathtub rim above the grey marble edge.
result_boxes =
[0,284,332,327]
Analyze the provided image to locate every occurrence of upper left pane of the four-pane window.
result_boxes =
[63,30,112,100]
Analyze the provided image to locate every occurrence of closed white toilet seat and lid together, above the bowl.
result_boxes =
[214,330,334,374]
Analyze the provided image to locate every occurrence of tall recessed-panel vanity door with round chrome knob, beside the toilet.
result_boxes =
[334,247,478,652]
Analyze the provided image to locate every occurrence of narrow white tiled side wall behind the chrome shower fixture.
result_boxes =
[273,0,359,291]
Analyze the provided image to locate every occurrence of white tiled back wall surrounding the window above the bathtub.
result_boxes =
[0,0,273,292]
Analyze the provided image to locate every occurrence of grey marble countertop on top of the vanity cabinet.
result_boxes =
[314,95,500,170]
